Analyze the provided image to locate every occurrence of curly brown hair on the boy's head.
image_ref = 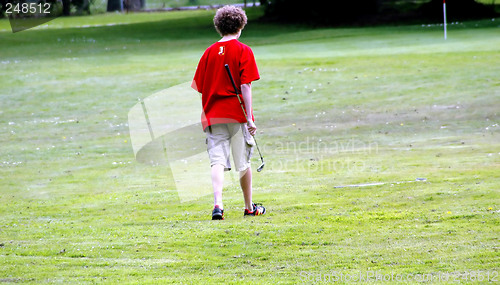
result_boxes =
[214,5,247,36]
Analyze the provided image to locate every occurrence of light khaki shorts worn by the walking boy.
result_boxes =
[206,123,255,171]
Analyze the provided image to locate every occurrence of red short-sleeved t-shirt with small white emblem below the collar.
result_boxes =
[191,39,260,129]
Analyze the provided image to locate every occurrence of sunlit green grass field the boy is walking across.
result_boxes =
[0,7,500,284]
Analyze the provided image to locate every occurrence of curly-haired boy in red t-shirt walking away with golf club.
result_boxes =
[191,6,266,220]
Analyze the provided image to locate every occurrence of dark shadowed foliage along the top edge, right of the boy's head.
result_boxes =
[264,0,498,25]
